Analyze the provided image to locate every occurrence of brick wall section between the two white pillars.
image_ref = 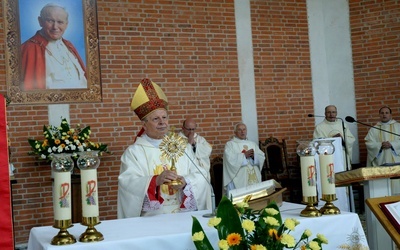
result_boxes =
[251,0,314,165]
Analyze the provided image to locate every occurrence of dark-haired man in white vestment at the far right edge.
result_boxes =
[365,106,400,194]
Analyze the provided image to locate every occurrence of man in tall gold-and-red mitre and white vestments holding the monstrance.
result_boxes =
[118,79,211,218]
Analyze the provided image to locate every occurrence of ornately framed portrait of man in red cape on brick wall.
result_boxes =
[3,0,102,105]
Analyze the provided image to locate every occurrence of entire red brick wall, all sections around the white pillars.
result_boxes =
[0,0,399,243]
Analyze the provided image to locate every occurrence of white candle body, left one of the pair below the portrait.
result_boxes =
[53,171,72,220]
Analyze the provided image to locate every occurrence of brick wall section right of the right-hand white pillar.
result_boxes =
[350,0,400,165]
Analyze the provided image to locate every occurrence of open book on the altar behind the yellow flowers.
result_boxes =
[228,180,281,204]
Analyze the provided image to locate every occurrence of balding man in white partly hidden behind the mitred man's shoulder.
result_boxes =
[179,118,212,182]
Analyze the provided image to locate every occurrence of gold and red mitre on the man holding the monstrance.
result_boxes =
[131,78,168,120]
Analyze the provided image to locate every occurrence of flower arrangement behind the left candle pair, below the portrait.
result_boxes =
[28,118,111,161]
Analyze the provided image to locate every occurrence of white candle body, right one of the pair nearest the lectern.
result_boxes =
[319,154,336,195]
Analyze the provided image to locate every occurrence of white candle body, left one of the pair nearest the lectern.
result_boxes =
[300,156,317,197]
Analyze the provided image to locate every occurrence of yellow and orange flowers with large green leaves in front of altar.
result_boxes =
[192,197,328,250]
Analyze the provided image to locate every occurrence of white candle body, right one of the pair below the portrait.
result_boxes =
[81,169,99,217]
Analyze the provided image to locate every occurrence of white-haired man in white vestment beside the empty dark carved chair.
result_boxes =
[223,123,265,194]
